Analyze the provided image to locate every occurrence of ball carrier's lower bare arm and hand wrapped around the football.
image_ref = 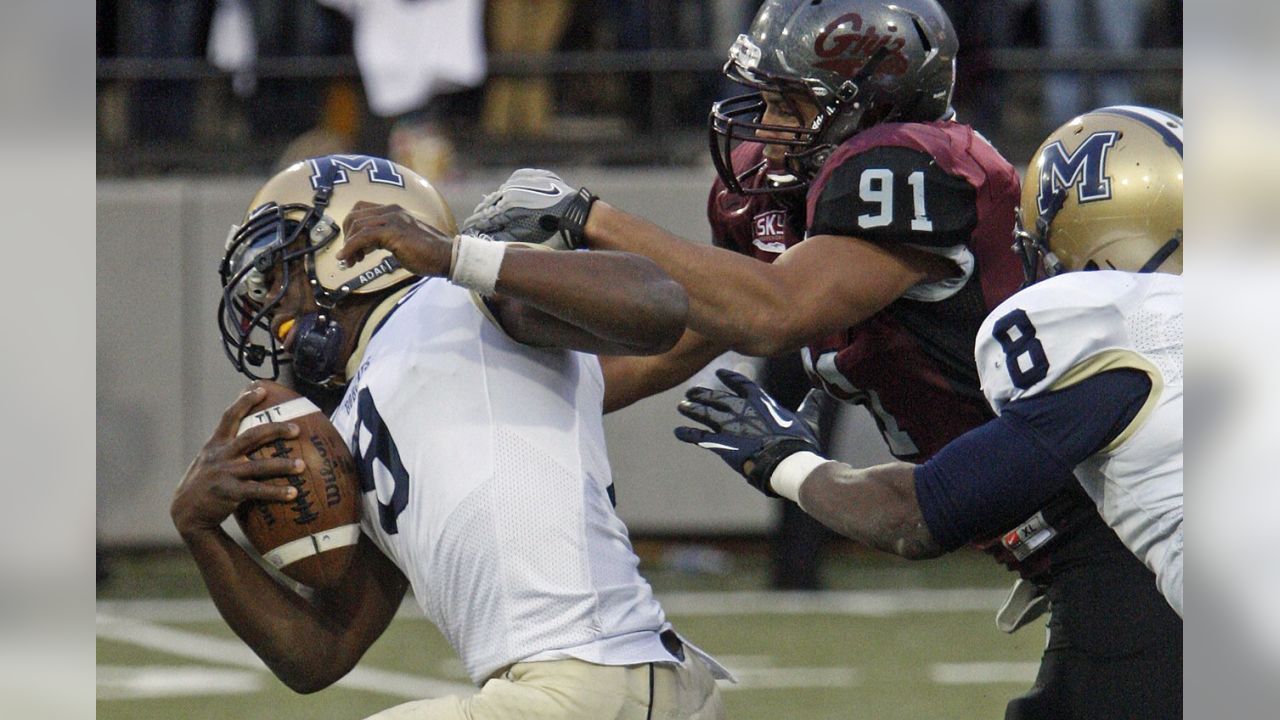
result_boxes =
[170,388,408,693]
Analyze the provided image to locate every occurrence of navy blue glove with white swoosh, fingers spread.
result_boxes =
[676,370,819,497]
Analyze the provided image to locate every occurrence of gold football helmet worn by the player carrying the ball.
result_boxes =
[218,155,458,384]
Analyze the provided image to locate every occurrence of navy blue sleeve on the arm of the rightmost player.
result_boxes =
[915,370,1151,551]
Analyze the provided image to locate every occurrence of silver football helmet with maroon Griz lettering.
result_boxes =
[710,0,960,195]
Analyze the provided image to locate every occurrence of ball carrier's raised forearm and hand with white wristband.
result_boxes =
[338,202,689,355]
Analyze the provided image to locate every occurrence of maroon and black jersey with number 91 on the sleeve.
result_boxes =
[804,122,1023,462]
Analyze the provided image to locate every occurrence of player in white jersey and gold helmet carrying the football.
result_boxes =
[170,155,727,720]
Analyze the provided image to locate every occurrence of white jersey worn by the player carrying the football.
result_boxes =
[333,279,673,684]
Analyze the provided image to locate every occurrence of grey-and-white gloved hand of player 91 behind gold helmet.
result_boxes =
[462,168,595,250]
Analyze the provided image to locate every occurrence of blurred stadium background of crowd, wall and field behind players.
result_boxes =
[96,0,1183,720]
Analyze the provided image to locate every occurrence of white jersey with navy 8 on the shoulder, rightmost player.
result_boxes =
[974,272,1183,615]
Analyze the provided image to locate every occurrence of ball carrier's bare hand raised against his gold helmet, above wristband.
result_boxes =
[337,200,453,278]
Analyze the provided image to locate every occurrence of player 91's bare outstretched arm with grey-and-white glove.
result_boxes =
[465,169,959,356]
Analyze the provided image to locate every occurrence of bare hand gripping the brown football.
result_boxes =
[169,388,305,537]
